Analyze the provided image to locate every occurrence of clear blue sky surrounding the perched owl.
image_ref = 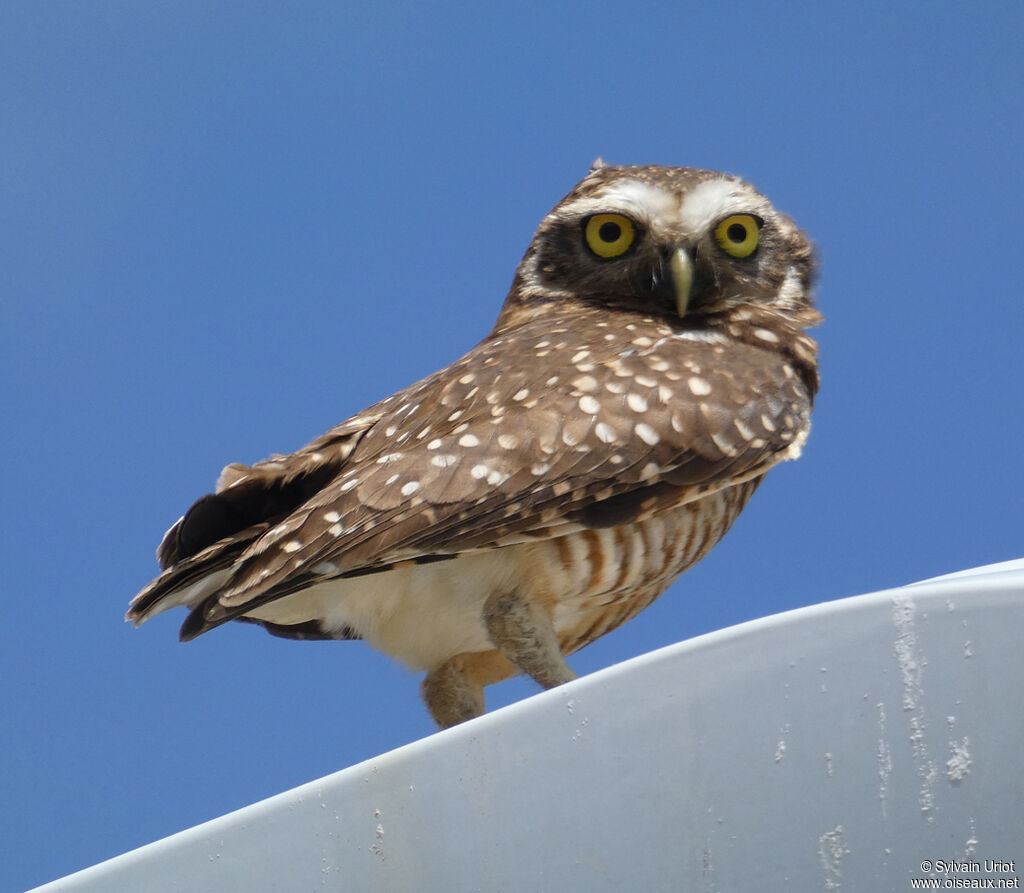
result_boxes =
[0,0,1024,890]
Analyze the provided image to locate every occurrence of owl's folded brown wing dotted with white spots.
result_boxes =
[132,311,813,638]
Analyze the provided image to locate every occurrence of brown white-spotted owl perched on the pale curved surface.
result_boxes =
[127,161,820,727]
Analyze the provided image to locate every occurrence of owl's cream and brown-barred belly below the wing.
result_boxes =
[241,481,757,670]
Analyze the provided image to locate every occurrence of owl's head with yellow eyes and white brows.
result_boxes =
[503,161,814,327]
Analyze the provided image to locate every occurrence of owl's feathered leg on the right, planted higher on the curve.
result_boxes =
[483,592,577,688]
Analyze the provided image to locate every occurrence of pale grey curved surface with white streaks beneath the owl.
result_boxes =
[32,561,1024,893]
